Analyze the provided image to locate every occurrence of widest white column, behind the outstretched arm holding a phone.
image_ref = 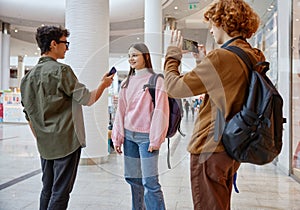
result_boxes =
[66,0,109,163]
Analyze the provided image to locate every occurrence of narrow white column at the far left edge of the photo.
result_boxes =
[0,23,10,90]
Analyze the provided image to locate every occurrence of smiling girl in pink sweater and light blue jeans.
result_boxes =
[112,43,169,210]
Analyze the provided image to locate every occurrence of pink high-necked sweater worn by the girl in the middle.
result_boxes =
[112,69,169,147]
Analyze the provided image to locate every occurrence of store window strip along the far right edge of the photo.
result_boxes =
[292,0,300,179]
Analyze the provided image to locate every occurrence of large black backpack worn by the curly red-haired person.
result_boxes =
[222,46,286,165]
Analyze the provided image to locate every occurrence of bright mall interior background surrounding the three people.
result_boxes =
[0,0,300,210]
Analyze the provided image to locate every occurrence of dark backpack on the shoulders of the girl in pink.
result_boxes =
[144,74,185,169]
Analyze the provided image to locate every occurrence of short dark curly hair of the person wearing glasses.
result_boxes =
[35,26,70,55]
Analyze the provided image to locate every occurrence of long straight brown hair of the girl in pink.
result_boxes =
[121,43,154,88]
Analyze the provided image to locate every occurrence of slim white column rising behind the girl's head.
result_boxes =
[144,0,163,72]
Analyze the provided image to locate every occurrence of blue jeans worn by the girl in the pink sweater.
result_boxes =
[124,130,166,210]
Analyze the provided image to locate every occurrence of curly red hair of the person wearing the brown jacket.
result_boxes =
[204,0,260,39]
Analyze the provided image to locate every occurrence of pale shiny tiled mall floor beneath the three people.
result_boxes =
[0,117,300,210]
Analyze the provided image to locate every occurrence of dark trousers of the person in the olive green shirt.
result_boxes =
[40,148,81,210]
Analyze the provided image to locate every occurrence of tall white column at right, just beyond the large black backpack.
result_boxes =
[277,0,293,175]
